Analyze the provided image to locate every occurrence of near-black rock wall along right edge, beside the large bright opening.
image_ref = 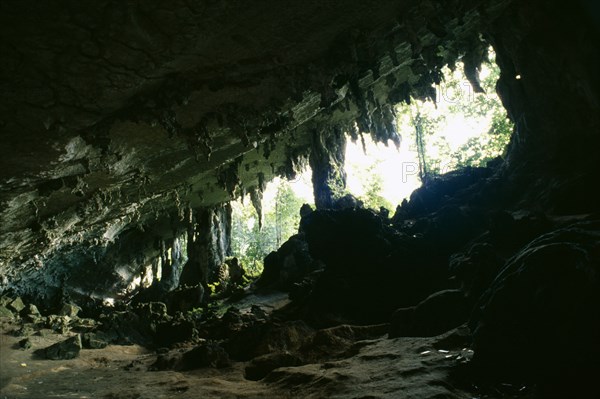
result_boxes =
[485,1,600,214]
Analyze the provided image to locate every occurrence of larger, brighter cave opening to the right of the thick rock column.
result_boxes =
[345,47,514,210]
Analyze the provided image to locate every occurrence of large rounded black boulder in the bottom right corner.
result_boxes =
[470,222,600,397]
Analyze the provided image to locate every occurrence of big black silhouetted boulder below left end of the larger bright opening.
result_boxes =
[301,208,453,324]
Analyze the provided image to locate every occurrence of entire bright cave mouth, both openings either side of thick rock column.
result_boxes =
[232,47,514,275]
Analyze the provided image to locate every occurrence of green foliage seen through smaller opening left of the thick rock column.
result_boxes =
[231,180,304,277]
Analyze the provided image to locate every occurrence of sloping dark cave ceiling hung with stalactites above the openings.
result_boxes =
[0,0,510,290]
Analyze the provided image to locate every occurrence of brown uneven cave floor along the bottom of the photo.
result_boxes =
[0,326,512,399]
